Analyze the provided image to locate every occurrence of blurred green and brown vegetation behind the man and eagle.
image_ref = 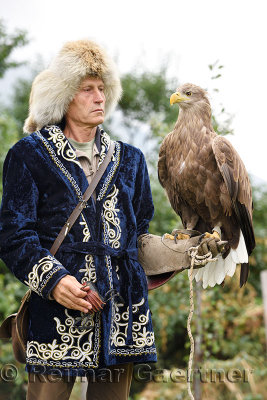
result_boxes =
[0,21,267,400]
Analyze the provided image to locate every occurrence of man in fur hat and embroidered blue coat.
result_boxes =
[0,40,157,400]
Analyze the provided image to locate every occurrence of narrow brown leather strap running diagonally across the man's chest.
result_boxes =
[50,141,115,256]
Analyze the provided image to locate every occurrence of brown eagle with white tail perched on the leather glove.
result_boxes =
[158,83,255,288]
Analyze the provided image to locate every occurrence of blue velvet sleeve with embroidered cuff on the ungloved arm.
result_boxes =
[0,148,70,298]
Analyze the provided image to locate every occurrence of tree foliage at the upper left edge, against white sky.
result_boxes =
[0,20,28,78]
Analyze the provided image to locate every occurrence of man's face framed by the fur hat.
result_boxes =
[66,77,106,127]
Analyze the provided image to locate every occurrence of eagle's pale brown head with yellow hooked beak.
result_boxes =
[170,83,210,109]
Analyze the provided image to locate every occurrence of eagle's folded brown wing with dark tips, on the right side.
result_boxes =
[212,136,255,255]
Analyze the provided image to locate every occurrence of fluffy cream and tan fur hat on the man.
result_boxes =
[23,40,122,133]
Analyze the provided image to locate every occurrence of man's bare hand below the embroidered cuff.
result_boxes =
[51,275,92,313]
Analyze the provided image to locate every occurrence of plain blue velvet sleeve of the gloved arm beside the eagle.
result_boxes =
[133,153,154,237]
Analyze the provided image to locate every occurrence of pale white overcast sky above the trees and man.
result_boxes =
[0,0,267,182]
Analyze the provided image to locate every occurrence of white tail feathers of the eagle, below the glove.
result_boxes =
[193,231,248,289]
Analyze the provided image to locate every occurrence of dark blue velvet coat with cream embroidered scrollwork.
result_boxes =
[0,125,156,375]
